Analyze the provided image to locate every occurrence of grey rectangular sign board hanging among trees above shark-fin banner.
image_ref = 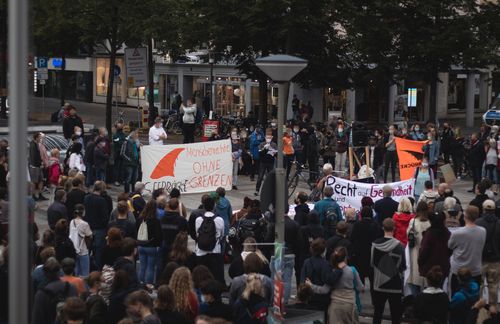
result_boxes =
[125,47,148,87]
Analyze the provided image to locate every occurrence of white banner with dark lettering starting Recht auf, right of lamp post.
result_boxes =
[326,177,415,212]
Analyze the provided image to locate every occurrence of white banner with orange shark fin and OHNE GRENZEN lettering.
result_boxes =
[141,139,233,193]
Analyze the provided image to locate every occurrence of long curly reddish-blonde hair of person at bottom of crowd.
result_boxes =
[168,267,194,314]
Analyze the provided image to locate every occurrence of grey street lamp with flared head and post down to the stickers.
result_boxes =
[255,55,307,243]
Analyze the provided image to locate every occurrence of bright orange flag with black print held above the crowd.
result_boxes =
[396,137,427,181]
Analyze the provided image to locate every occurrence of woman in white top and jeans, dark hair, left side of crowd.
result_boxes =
[69,205,93,277]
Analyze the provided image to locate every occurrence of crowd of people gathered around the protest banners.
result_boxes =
[0,99,500,324]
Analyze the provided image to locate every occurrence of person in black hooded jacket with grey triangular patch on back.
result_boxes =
[370,218,406,324]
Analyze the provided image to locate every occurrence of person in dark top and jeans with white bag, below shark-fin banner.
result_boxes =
[136,199,162,284]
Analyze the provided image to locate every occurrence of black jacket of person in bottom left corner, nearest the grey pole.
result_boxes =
[31,280,77,324]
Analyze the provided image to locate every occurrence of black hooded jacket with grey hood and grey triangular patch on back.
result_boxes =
[371,237,406,294]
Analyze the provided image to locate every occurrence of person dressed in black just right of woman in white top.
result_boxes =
[84,181,111,269]
